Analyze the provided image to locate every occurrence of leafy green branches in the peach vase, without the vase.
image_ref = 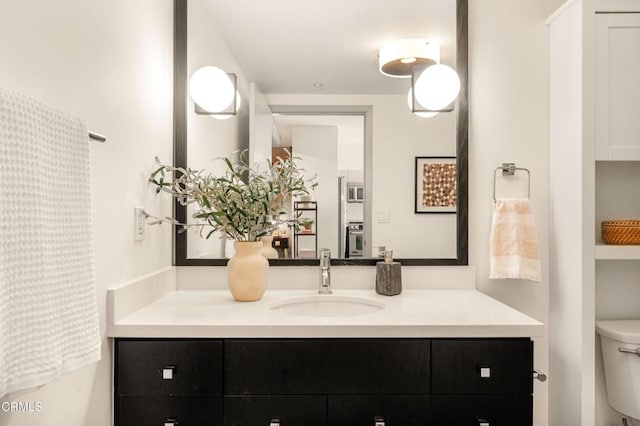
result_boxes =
[149,150,317,241]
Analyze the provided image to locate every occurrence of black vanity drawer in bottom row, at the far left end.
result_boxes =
[115,396,222,426]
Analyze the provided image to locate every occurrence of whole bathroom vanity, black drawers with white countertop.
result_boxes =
[109,289,542,426]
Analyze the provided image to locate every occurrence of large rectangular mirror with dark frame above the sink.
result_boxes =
[174,0,468,265]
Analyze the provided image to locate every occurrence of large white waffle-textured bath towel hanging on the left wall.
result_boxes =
[0,88,101,397]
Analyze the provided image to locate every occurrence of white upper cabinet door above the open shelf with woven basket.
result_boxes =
[596,13,640,161]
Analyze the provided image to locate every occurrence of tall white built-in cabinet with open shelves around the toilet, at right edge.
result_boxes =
[547,0,640,426]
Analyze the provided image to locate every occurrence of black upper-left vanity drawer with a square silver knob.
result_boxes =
[116,340,222,395]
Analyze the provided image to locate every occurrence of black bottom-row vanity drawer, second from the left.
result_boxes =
[224,396,327,426]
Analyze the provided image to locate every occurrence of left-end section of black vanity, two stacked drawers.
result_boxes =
[114,339,224,426]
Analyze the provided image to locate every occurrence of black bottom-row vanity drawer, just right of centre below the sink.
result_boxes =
[328,395,429,426]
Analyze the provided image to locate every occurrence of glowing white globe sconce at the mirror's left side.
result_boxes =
[189,66,240,119]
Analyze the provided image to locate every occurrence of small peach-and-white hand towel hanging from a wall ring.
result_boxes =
[489,198,541,281]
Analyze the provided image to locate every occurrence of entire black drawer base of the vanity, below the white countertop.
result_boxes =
[115,338,533,426]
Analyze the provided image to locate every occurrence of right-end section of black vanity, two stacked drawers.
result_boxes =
[429,339,533,426]
